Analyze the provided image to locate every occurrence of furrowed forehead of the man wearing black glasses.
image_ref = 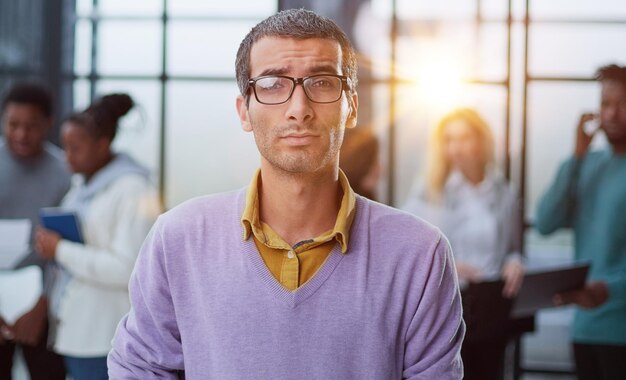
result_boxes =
[250,36,342,76]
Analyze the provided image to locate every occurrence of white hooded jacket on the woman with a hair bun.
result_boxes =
[54,173,159,357]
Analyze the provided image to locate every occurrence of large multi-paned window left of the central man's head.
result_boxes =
[71,0,277,208]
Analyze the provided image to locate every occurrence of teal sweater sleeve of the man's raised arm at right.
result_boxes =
[535,158,581,235]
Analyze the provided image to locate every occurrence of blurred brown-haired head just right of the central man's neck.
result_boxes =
[339,127,381,200]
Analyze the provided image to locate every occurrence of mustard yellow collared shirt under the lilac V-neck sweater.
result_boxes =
[241,169,356,290]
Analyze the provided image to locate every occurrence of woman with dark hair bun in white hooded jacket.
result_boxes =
[36,94,158,380]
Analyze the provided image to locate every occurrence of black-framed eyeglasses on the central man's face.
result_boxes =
[248,74,349,105]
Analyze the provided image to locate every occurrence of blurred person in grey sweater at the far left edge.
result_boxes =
[0,83,70,380]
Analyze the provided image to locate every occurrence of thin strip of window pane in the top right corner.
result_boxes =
[530,0,626,20]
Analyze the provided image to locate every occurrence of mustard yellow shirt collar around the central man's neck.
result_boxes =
[241,169,356,253]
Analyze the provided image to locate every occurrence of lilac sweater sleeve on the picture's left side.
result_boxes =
[108,221,184,379]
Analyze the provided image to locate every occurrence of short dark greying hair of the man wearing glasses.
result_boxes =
[235,9,357,96]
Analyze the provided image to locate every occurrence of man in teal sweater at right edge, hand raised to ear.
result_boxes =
[536,65,626,380]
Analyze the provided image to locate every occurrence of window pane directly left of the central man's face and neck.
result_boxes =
[165,81,259,208]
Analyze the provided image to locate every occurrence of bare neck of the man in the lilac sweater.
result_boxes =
[259,165,342,246]
